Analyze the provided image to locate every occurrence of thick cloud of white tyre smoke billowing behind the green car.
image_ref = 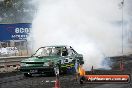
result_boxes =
[28,0,131,69]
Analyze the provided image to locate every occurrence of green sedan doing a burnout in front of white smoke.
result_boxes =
[20,46,84,77]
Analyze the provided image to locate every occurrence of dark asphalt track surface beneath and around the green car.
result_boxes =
[0,57,132,88]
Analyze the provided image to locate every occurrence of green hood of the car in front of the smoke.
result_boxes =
[21,56,60,63]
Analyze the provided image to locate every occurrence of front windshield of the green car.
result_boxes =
[34,47,61,57]
